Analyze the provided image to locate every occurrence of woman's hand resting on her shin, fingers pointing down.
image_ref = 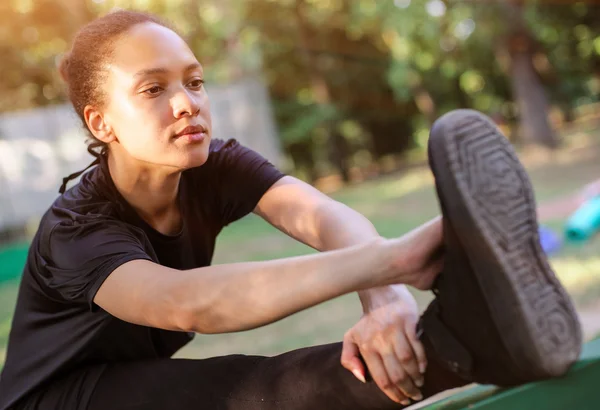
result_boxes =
[341,286,427,405]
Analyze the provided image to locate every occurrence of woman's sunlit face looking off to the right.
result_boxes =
[98,23,211,169]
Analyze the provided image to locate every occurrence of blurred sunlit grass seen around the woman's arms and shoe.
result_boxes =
[0,130,600,364]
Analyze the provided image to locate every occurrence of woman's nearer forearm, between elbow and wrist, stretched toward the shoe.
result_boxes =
[177,239,393,333]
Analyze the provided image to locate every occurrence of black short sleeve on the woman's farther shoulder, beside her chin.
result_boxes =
[210,139,285,226]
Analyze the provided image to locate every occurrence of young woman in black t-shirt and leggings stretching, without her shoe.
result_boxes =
[0,11,450,410]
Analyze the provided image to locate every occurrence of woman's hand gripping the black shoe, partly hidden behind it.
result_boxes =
[379,216,443,290]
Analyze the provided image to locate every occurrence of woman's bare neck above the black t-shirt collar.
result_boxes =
[108,151,181,234]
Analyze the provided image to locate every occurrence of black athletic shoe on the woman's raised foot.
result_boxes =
[419,110,582,386]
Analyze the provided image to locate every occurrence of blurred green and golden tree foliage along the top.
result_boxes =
[0,0,600,178]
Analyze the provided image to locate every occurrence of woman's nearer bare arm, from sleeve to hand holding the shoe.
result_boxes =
[94,224,441,333]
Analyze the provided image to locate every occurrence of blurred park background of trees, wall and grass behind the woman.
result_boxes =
[0,0,600,367]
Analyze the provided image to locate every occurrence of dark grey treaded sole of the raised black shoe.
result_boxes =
[436,110,581,376]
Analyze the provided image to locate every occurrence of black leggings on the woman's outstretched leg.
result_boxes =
[20,343,464,410]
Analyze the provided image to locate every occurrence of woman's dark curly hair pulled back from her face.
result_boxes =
[59,10,173,158]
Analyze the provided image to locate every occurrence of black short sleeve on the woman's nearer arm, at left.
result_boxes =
[41,219,153,310]
